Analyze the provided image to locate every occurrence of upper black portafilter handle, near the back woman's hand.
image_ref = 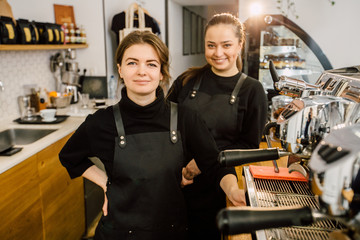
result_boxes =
[218,148,291,167]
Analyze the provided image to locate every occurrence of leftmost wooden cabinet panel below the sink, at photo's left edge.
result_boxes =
[0,156,43,240]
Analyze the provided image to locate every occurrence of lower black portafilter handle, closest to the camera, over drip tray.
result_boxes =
[216,207,314,235]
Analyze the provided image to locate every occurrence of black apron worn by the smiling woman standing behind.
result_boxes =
[183,73,247,240]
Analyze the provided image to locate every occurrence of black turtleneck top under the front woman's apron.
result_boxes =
[59,88,235,181]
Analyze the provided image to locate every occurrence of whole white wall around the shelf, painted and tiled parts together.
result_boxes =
[0,0,106,122]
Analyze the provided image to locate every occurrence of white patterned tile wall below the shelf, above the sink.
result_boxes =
[0,50,58,124]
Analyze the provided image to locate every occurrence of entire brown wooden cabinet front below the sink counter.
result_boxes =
[0,135,85,240]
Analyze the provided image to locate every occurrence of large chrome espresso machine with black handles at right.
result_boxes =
[218,62,360,240]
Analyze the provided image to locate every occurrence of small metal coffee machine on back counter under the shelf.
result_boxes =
[50,49,81,103]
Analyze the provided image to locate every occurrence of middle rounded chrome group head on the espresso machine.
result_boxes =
[277,96,359,154]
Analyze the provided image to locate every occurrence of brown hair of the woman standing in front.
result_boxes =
[115,30,170,91]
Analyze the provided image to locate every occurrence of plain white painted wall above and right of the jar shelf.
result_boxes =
[8,0,106,76]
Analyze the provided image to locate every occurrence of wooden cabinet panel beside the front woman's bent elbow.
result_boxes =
[37,136,85,240]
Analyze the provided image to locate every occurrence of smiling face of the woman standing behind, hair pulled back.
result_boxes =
[205,24,242,76]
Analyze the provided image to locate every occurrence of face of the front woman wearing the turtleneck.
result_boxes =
[118,43,163,103]
